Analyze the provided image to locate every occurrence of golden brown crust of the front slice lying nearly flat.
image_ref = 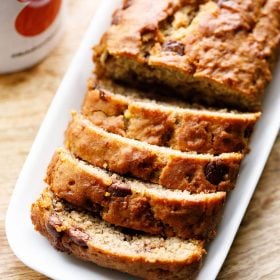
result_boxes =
[32,189,204,280]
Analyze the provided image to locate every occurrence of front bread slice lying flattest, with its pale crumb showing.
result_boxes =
[32,189,205,280]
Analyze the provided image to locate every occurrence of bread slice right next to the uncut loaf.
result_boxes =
[82,77,260,154]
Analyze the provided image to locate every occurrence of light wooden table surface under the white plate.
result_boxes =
[0,0,280,280]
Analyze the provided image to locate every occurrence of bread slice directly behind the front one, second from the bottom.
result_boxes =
[45,148,226,239]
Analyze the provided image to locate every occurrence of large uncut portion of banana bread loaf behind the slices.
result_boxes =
[94,0,280,111]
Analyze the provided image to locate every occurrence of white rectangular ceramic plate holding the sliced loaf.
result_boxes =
[6,0,280,280]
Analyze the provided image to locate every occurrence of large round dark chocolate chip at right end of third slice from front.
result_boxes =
[204,162,229,185]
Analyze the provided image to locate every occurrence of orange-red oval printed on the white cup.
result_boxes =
[15,0,62,37]
